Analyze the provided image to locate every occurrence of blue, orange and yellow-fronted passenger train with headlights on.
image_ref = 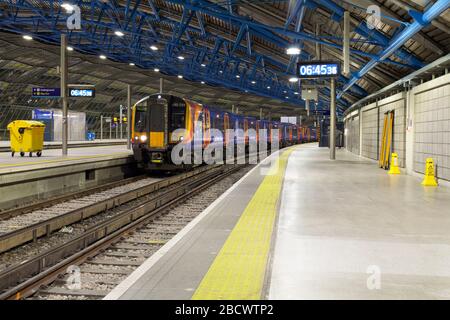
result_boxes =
[131,93,317,170]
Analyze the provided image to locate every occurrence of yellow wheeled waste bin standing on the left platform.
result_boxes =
[8,120,45,157]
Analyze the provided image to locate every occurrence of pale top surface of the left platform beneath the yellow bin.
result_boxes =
[0,143,132,174]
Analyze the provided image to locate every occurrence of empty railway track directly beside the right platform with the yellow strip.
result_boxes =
[0,165,246,299]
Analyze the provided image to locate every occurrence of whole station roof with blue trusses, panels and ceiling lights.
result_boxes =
[0,0,450,114]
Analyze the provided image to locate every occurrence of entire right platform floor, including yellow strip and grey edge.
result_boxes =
[105,144,450,299]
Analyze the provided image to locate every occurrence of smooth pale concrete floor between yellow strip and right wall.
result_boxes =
[269,146,450,299]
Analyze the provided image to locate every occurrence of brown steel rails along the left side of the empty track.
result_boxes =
[0,165,241,300]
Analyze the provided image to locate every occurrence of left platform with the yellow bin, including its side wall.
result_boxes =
[0,145,136,210]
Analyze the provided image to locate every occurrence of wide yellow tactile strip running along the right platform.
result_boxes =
[192,148,295,300]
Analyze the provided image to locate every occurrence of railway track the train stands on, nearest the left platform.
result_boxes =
[0,168,211,253]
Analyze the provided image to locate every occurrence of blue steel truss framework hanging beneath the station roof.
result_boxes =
[0,0,442,112]
